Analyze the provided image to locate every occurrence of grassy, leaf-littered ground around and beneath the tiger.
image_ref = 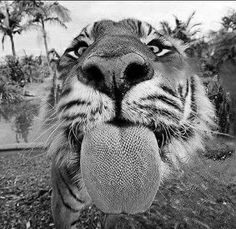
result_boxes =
[0,138,236,229]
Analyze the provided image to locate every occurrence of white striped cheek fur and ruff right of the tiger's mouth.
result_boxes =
[122,75,215,174]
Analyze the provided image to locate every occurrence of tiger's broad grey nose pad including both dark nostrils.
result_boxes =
[82,53,153,91]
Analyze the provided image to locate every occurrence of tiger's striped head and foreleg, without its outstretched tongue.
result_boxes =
[49,19,215,229]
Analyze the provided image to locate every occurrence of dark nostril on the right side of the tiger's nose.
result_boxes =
[124,63,151,84]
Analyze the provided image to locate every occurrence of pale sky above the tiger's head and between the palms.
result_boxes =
[0,1,236,57]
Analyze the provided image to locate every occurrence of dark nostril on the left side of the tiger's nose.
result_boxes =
[82,64,104,85]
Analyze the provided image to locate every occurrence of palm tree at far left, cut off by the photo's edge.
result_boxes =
[0,1,27,58]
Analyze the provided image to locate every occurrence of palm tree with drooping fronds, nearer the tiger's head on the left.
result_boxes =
[28,1,71,63]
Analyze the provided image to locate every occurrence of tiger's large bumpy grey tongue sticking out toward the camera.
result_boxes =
[81,124,160,214]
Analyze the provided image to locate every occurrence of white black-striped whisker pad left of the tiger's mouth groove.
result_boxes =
[58,77,115,133]
